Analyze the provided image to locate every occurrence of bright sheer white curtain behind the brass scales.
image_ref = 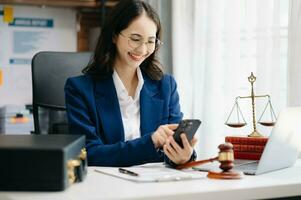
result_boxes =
[172,0,288,159]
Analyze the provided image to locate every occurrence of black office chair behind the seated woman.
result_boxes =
[31,52,91,134]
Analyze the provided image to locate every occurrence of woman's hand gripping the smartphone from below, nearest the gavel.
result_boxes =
[163,133,197,165]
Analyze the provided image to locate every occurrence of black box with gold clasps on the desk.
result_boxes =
[0,134,87,191]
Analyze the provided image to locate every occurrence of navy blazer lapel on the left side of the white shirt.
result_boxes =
[95,77,124,144]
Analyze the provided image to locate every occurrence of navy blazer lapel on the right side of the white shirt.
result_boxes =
[140,76,164,135]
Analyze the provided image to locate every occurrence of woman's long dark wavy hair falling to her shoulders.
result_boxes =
[83,0,163,80]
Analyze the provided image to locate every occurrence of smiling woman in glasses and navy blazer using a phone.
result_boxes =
[65,0,196,166]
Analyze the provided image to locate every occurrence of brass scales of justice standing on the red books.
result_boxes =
[225,72,276,137]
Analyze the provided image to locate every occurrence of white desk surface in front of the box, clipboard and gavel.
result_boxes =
[0,159,301,200]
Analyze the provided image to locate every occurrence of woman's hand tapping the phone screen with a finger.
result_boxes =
[151,124,178,149]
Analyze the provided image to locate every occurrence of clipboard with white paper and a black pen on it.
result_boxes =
[95,163,206,182]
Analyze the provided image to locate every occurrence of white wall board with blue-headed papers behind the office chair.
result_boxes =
[0,5,77,107]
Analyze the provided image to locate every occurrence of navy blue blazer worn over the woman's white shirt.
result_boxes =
[65,74,183,166]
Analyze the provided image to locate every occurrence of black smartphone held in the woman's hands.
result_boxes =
[173,119,201,148]
